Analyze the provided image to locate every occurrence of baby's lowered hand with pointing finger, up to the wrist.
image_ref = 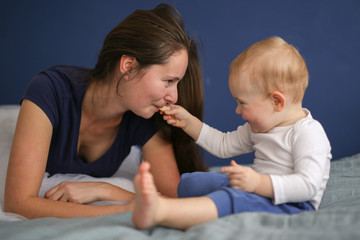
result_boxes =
[221,160,261,193]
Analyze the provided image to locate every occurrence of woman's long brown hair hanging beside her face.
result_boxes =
[91,4,207,173]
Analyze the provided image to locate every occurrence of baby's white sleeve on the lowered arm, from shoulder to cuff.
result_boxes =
[271,121,331,207]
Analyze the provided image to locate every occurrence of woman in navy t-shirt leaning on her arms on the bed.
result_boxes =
[5,4,205,218]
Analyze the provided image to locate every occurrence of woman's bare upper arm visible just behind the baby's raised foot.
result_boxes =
[142,133,180,197]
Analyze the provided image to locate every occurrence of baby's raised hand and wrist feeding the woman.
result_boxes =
[162,105,203,141]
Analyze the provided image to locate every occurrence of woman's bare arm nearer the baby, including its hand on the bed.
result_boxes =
[45,134,180,203]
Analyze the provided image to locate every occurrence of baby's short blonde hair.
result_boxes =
[230,37,309,103]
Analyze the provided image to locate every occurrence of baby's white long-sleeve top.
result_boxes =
[197,109,332,209]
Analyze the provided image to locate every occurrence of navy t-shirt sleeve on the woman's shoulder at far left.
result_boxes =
[22,72,59,127]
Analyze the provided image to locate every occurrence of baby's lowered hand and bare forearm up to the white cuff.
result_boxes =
[221,160,274,199]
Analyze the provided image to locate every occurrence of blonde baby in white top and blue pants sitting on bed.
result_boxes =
[133,37,331,229]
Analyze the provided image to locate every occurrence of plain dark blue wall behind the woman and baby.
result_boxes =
[0,0,360,165]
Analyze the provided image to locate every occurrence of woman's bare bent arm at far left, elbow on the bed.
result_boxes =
[4,100,132,218]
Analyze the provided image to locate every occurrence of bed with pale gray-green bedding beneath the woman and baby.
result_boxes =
[0,106,360,240]
